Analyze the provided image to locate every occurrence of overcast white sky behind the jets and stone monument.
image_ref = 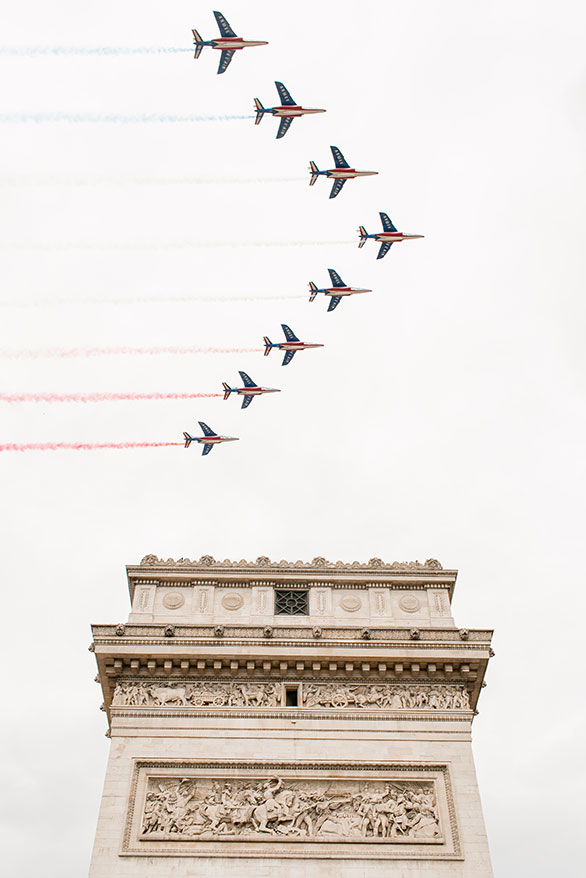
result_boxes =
[0,0,586,878]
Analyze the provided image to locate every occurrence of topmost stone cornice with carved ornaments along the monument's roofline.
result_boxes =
[126,555,458,600]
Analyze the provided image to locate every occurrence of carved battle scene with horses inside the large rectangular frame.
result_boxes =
[139,776,443,843]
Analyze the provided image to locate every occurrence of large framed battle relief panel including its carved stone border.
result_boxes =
[123,763,458,857]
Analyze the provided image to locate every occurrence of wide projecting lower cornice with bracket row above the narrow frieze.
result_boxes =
[90,623,492,709]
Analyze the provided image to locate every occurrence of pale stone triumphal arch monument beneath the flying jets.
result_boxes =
[90,555,492,878]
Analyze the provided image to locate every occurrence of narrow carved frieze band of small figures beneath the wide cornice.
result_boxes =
[112,680,470,711]
